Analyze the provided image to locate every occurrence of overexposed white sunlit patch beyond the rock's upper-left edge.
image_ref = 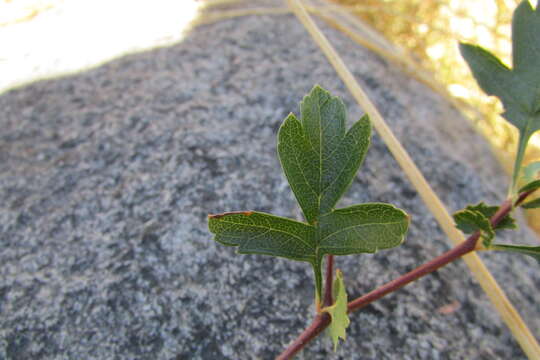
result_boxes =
[0,0,199,93]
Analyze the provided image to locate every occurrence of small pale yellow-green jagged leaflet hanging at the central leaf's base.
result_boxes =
[321,269,350,351]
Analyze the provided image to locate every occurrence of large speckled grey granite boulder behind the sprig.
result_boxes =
[0,2,540,359]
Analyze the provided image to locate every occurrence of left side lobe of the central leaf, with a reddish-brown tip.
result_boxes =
[208,211,317,263]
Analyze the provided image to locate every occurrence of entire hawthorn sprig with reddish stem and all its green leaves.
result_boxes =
[208,0,540,359]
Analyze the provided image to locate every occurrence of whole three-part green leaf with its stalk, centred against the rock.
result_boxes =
[208,86,409,301]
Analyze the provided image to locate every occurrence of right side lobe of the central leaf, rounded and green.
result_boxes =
[319,203,409,255]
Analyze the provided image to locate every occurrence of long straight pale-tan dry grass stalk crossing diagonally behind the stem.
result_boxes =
[288,0,540,359]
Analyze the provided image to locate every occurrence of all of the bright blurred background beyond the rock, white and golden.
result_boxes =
[0,0,540,233]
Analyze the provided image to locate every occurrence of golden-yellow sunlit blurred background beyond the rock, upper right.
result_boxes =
[332,0,540,233]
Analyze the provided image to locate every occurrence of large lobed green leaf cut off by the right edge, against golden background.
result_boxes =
[460,0,540,195]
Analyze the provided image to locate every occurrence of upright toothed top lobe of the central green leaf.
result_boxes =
[278,86,371,224]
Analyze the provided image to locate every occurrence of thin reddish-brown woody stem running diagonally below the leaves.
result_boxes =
[277,191,534,360]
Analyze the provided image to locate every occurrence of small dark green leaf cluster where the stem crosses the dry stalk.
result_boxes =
[453,202,516,247]
